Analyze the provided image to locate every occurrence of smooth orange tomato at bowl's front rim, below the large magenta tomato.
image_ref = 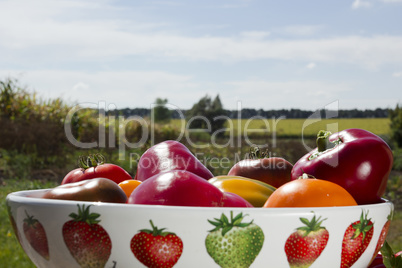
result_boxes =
[264,174,357,208]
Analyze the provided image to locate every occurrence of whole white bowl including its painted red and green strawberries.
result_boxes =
[6,190,393,268]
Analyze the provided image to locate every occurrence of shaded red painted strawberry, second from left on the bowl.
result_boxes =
[62,205,112,268]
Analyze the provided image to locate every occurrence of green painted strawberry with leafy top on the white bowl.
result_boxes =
[205,211,264,268]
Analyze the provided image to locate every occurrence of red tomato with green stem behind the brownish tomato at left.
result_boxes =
[61,154,132,184]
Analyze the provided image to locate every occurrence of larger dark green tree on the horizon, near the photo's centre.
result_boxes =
[186,95,226,136]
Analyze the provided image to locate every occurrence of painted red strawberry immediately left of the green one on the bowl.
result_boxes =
[130,220,183,268]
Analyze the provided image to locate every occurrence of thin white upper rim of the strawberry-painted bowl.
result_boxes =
[6,188,394,213]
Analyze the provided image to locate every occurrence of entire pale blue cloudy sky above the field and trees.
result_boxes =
[0,0,402,110]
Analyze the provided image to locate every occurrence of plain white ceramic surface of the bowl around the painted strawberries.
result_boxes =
[7,190,393,268]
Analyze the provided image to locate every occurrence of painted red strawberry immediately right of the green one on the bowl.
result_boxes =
[285,215,329,268]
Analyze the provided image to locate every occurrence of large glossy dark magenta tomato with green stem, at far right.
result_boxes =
[292,128,393,205]
